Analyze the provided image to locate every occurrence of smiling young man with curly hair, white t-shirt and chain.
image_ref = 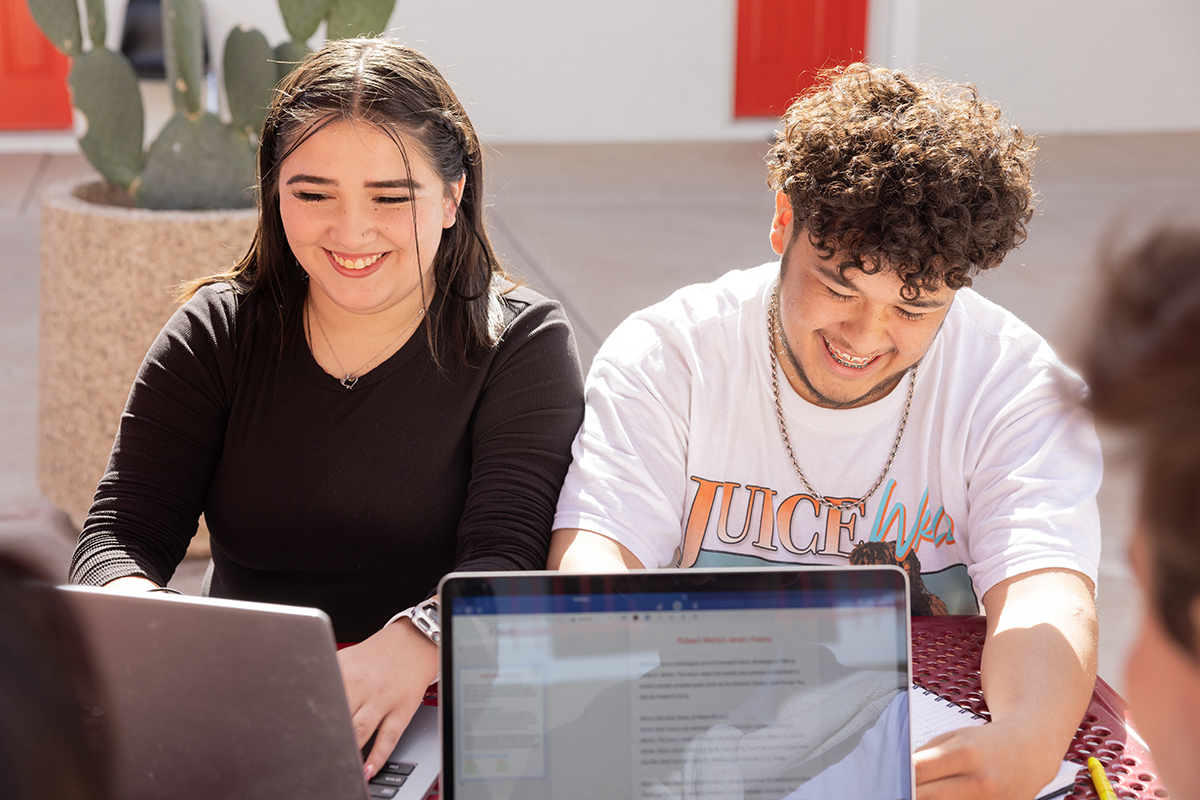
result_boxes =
[550,65,1102,800]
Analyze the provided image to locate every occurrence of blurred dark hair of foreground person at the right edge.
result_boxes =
[1082,227,1200,656]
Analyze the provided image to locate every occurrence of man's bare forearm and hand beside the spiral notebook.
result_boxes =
[913,570,1097,800]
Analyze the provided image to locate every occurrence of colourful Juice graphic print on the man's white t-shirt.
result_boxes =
[677,475,979,616]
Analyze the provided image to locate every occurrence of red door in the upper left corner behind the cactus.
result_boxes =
[0,0,71,131]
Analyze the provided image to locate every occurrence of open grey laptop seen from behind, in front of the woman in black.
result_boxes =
[60,587,440,800]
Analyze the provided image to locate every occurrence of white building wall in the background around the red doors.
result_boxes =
[199,0,1200,144]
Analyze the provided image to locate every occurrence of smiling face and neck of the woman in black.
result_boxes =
[280,120,466,386]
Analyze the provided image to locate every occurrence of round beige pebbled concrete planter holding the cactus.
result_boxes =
[37,176,258,555]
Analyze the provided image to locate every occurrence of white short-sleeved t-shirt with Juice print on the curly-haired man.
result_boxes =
[554,264,1102,613]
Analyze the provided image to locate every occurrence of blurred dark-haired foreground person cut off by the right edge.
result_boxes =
[1084,223,1200,798]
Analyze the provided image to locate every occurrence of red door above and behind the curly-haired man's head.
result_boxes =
[733,0,866,116]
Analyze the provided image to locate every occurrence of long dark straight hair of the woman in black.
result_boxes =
[185,38,504,362]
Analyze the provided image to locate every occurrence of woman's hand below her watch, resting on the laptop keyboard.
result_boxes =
[337,619,438,781]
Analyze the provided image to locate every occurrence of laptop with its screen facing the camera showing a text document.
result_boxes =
[440,566,912,800]
